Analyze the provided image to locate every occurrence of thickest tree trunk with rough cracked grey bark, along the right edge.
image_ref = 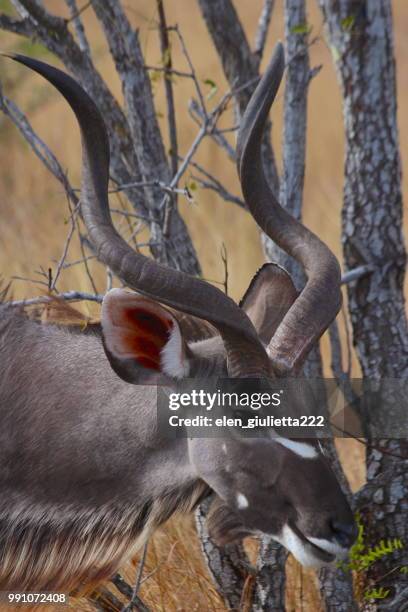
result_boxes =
[320,0,408,609]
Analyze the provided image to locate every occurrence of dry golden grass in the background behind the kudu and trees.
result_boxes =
[0,0,408,612]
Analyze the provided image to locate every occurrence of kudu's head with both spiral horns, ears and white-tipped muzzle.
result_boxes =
[6,45,355,565]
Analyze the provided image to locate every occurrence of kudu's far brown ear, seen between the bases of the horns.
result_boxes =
[240,263,298,346]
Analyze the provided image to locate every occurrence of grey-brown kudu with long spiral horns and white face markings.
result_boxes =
[0,45,355,590]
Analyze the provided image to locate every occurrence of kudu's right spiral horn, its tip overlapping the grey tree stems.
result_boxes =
[237,44,341,375]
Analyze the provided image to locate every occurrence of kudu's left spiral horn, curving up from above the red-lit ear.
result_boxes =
[7,54,270,377]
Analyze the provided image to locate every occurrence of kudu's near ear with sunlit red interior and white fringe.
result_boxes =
[101,289,190,384]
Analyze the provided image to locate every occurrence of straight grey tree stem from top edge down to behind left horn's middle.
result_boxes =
[92,0,200,275]
